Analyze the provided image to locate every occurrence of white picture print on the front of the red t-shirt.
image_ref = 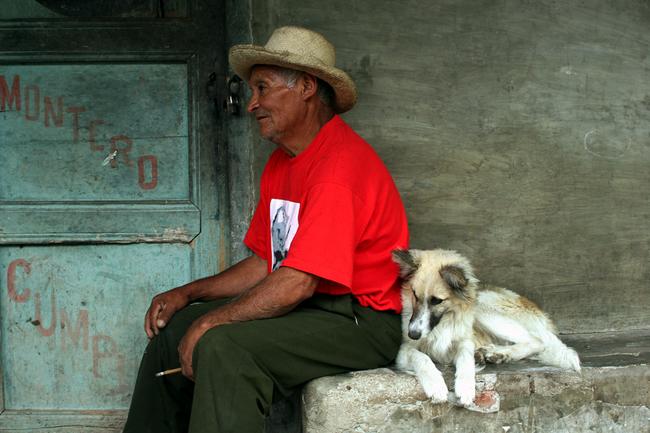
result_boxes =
[271,198,300,271]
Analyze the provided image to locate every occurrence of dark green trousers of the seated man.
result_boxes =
[124,294,401,433]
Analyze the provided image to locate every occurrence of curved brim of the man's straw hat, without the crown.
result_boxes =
[228,45,357,113]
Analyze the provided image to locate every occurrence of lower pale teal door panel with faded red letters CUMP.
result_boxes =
[0,244,191,410]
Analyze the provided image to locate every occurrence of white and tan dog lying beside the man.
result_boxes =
[392,249,580,406]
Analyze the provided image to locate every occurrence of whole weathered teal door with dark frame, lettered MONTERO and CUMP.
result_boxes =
[0,0,227,433]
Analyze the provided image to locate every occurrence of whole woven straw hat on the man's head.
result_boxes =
[228,27,357,113]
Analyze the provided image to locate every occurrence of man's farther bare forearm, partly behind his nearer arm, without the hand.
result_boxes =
[178,254,267,302]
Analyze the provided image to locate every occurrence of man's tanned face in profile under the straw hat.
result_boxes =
[247,66,304,145]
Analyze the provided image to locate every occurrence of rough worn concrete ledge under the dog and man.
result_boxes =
[298,330,650,433]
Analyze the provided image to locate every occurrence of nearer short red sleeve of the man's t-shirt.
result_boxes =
[282,183,363,287]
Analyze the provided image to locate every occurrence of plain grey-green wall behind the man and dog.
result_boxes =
[230,0,650,333]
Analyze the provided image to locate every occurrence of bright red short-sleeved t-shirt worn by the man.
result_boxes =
[244,116,408,312]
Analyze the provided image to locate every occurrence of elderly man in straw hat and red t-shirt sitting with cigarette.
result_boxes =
[124,27,408,433]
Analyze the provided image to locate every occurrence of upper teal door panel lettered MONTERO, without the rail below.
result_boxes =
[0,63,190,201]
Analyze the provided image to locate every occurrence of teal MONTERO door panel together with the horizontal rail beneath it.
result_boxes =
[0,62,200,243]
